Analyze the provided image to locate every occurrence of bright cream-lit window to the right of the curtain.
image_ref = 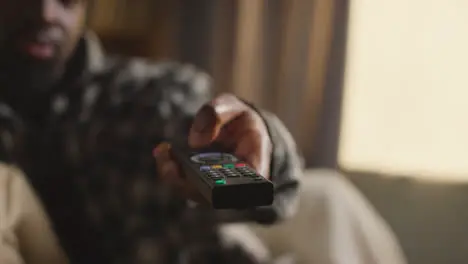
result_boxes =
[339,0,468,181]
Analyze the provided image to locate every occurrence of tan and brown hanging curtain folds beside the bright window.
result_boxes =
[211,0,335,163]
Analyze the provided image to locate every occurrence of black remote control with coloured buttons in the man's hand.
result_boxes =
[172,146,274,209]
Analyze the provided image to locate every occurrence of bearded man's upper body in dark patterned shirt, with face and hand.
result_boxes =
[0,0,301,263]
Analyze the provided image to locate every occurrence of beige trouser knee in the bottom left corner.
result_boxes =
[0,164,68,264]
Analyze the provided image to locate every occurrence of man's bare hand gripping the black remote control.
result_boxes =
[154,94,272,202]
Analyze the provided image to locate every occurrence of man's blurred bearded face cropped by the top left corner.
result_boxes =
[0,0,87,88]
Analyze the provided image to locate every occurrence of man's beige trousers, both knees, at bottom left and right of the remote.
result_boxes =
[0,163,405,264]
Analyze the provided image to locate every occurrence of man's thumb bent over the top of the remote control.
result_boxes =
[189,94,249,148]
